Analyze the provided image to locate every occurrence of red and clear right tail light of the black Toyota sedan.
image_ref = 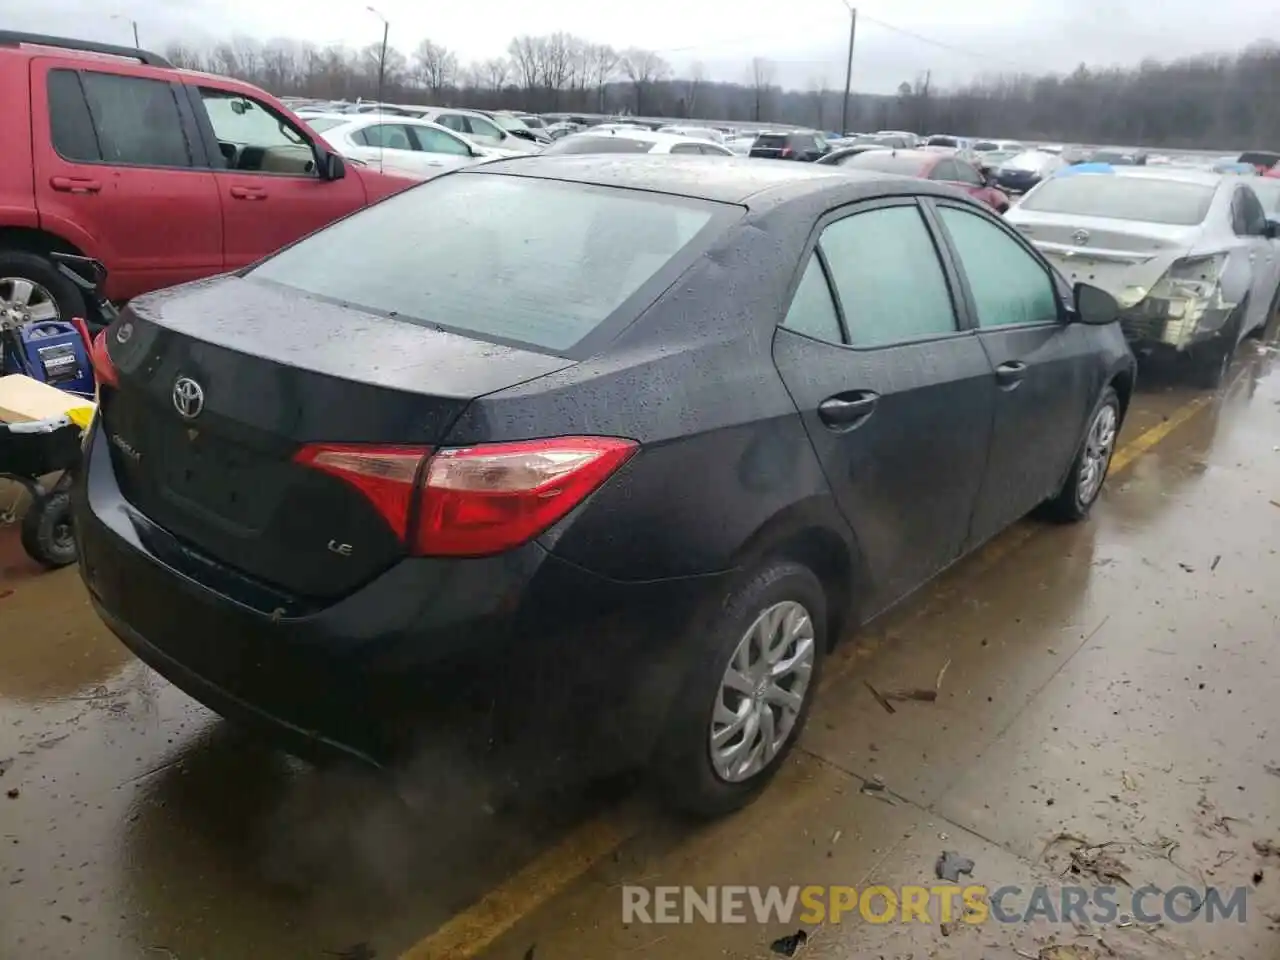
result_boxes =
[294,436,636,557]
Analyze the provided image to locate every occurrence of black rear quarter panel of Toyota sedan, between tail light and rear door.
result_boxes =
[448,216,856,580]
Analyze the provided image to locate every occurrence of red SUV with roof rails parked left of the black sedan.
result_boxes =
[0,31,413,320]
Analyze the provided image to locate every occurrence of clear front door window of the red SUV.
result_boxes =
[200,87,320,177]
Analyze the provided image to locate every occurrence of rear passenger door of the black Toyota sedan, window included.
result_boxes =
[773,200,995,611]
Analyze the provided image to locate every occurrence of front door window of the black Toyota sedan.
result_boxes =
[938,206,1057,326]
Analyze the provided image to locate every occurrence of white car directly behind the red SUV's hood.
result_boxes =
[302,114,521,179]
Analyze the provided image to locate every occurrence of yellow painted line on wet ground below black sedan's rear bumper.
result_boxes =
[399,812,639,960]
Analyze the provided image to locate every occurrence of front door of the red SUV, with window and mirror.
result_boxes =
[188,84,366,270]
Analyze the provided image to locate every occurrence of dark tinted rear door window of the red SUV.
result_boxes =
[59,70,192,168]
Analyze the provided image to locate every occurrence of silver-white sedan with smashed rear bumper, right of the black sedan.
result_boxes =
[1006,166,1280,387]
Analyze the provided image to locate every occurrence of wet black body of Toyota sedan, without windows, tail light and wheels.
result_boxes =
[73,157,1133,803]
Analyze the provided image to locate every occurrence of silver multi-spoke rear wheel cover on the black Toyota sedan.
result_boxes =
[709,600,815,783]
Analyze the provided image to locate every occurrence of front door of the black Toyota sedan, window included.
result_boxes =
[929,200,1103,543]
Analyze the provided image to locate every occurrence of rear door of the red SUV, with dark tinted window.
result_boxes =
[31,56,223,300]
